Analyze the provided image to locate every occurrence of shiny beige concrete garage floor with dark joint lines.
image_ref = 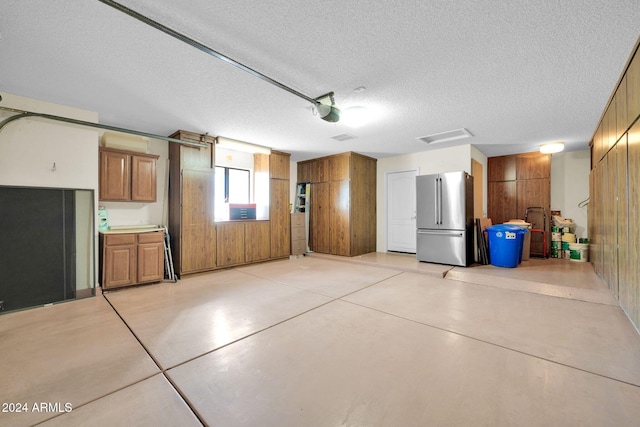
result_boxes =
[0,253,640,426]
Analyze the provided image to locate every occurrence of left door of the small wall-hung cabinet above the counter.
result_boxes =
[99,150,131,201]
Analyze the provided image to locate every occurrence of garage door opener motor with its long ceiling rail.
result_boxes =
[100,0,340,122]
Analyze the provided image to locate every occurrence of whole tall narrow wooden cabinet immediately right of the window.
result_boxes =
[269,151,291,258]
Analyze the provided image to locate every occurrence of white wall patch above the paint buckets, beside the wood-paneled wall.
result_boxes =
[551,150,591,237]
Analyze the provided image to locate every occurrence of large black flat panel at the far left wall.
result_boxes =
[0,187,76,311]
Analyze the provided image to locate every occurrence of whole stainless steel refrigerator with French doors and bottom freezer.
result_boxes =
[416,172,473,267]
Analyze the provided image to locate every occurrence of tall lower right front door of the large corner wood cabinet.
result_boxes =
[329,179,351,256]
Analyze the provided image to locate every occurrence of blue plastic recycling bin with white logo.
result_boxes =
[487,224,527,268]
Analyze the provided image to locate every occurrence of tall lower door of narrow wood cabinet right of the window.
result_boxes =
[269,179,291,258]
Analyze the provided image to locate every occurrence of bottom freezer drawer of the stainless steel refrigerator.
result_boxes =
[416,229,470,267]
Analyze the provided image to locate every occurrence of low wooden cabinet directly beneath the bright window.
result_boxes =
[216,221,270,267]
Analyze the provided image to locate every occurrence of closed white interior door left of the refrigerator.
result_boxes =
[386,170,418,253]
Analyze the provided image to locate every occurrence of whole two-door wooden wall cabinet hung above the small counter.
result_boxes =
[99,148,159,202]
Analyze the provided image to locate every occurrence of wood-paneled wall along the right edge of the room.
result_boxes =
[589,39,640,330]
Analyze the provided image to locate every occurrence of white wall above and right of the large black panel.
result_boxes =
[0,93,98,289]
